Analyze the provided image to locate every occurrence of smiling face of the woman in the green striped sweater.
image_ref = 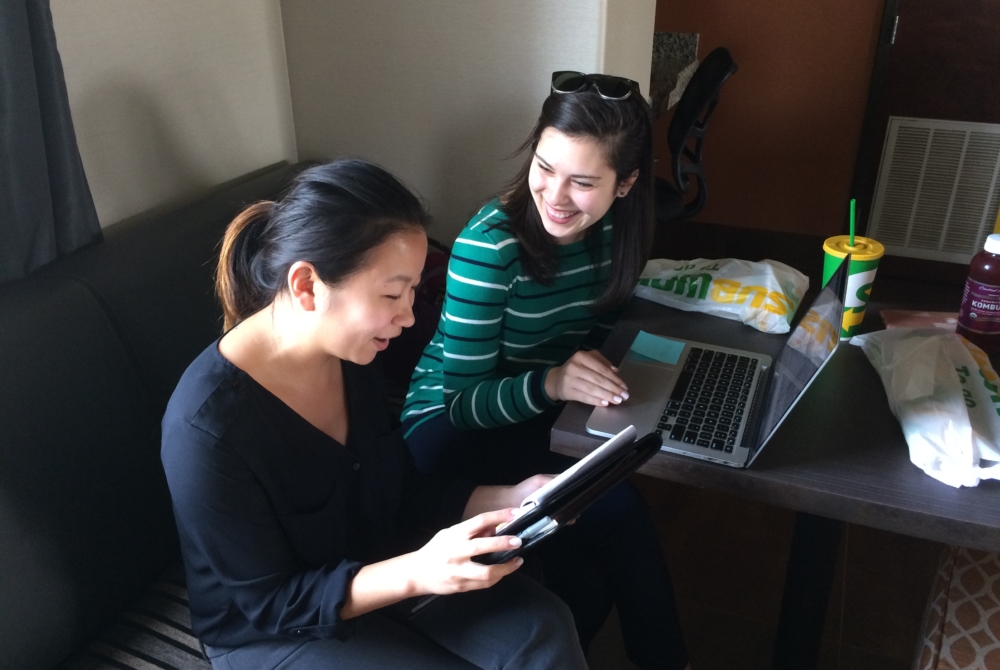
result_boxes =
[528,127,635,244]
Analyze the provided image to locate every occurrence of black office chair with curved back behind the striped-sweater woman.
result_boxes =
[655,47,736,223]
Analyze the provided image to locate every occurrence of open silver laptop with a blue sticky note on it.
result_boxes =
[587,256,850,468]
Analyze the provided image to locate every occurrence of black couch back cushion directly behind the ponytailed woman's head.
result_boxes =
[39,163,309,415]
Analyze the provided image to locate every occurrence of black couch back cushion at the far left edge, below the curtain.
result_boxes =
[0,279,177,668]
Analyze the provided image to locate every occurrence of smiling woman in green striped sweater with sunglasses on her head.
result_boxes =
[403,73,687,670]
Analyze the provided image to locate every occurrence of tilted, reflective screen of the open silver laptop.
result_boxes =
[751,255,848,449]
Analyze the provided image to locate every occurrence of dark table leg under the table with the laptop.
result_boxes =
[771,512,843,670]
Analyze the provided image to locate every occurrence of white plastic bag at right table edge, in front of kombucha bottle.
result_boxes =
[851,328,1000,487]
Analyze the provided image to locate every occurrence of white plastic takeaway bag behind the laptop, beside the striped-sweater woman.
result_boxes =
[635,258,809,333]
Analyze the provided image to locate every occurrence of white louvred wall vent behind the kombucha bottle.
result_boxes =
[868,116,1000,263]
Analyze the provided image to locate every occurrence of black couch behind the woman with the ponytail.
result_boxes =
[0,165,304,670]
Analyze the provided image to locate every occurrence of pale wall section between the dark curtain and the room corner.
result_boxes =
[51,0,296,226]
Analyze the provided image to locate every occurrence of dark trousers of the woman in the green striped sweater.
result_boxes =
[404,408,687,670]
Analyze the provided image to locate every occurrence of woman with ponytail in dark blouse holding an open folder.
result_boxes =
[161,161,586,670]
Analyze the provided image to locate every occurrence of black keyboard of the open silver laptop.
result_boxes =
[656,347,757,453]
